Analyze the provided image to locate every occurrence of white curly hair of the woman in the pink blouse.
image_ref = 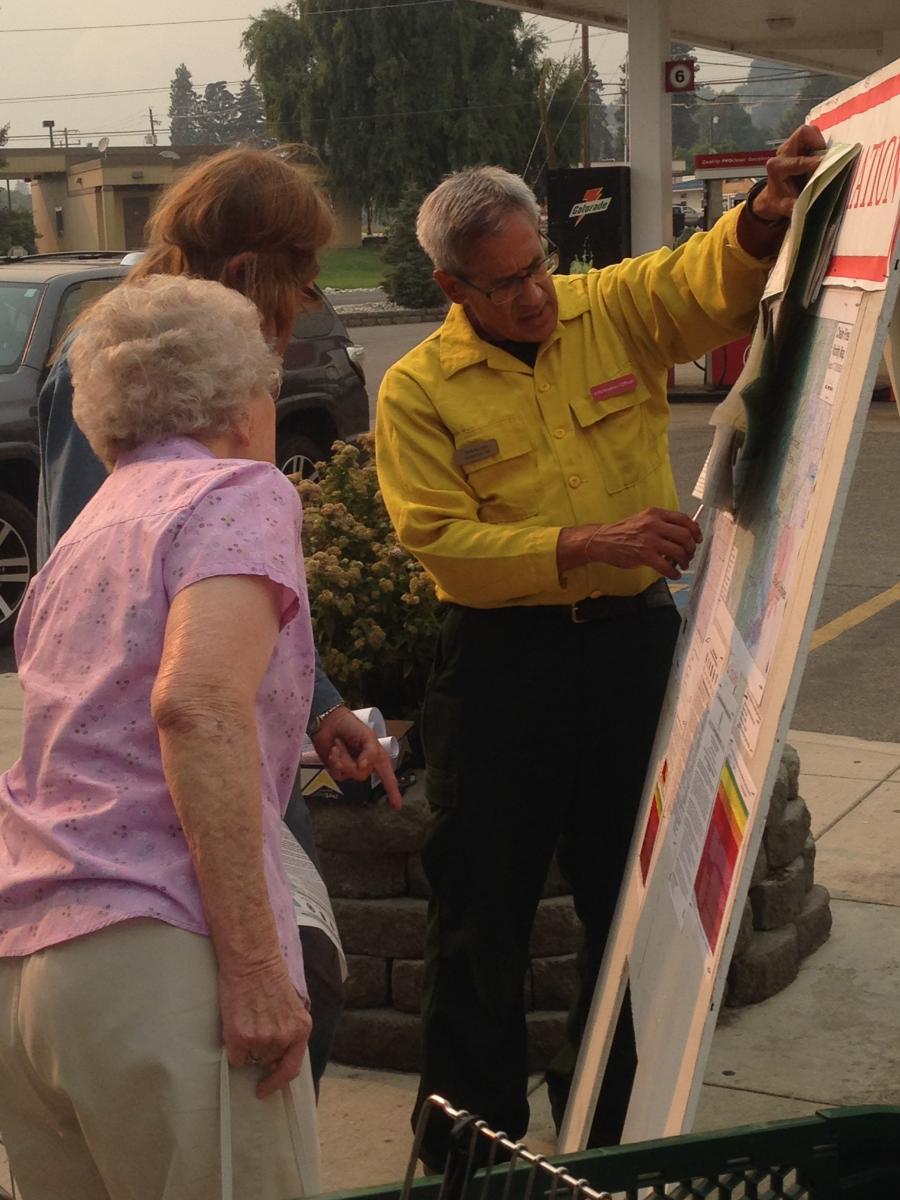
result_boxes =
[68,275,281,469]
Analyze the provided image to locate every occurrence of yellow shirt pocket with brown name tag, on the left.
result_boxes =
[454,418,539,524]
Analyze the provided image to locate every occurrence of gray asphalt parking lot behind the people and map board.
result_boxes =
[0,324,900,742]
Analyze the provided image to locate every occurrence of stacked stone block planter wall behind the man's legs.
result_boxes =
[310,748,830,1072]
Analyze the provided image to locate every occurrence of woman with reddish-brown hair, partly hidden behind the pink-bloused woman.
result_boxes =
[37,146,401,1099]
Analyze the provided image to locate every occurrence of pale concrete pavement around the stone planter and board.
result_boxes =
[0,674,900,1190]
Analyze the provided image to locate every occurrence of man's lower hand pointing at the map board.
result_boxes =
[583,509,703,580]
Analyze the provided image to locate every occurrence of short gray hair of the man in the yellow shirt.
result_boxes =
[415,167,540,274]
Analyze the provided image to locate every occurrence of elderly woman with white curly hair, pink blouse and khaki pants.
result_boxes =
[0,275,318,1200]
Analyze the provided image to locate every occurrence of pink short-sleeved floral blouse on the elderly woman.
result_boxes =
[0,438,314,996]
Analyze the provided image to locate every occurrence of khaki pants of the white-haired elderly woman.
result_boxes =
[0,920,319,1200]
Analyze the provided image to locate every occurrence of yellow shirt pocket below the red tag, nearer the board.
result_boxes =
[570,383,666,496]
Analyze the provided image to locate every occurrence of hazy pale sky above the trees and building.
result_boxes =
[0,0,745,146]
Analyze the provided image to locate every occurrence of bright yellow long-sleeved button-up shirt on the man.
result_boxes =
[376,210,769,608]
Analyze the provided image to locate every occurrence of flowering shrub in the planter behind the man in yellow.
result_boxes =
[296,437,440,720]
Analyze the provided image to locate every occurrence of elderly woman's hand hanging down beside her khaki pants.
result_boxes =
[218,958,312,1100]
